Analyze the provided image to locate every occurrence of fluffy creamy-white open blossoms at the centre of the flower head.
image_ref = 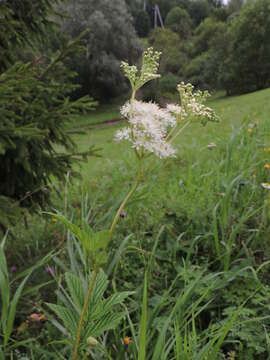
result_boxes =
[115,100,176,158]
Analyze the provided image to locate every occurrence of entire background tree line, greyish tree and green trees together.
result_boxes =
[49,0,270,102]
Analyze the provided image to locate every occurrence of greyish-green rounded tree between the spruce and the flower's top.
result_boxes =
[63,0,140,100]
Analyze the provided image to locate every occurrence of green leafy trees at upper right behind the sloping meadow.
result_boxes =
[125,0,270,96]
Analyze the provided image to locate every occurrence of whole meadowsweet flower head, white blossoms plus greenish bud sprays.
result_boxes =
[115,48,217,159]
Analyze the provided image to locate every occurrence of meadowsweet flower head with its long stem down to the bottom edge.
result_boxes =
[47,48,217,360]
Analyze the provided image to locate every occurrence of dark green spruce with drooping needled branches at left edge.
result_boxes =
[0,1,95,228]
